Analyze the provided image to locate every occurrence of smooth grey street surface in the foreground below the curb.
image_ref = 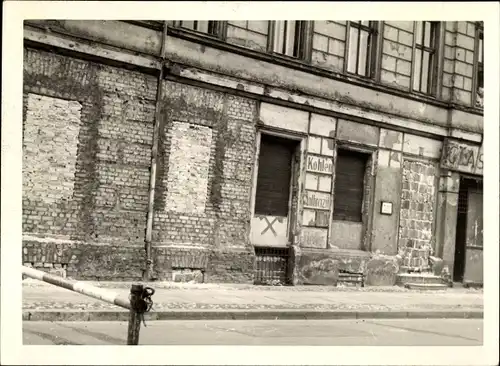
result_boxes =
[23,319,483,346]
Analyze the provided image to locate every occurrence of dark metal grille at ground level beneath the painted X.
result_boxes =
[254,247,291,285]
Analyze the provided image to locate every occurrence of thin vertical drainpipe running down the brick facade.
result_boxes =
[143,21,167,281]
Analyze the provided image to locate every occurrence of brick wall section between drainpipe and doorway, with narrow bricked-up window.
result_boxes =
[153,82,256,281]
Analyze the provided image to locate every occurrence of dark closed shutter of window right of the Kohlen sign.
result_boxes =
[333,149,369,222]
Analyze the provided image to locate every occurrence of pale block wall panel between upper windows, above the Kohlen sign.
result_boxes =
[311,20,346,72]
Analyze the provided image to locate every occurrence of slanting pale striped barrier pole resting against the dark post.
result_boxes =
[23,266,132,309]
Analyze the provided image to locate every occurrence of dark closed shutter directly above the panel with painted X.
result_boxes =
[255,134,297,216]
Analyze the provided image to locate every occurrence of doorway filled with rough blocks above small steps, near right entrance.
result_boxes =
[398,159,437,267]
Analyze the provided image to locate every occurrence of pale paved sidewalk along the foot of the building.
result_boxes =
[23,280,483,321]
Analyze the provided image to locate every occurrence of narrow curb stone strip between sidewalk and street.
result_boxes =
[23,310,483,322]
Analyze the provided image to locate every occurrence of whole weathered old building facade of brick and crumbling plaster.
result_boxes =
[23,20,483,285]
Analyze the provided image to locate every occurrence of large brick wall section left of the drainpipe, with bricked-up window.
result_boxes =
[23,49,156,279]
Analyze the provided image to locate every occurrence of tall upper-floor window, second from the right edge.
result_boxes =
[412,21,439,94]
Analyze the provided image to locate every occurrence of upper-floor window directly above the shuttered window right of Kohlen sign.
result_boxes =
[346,20,378,77]
